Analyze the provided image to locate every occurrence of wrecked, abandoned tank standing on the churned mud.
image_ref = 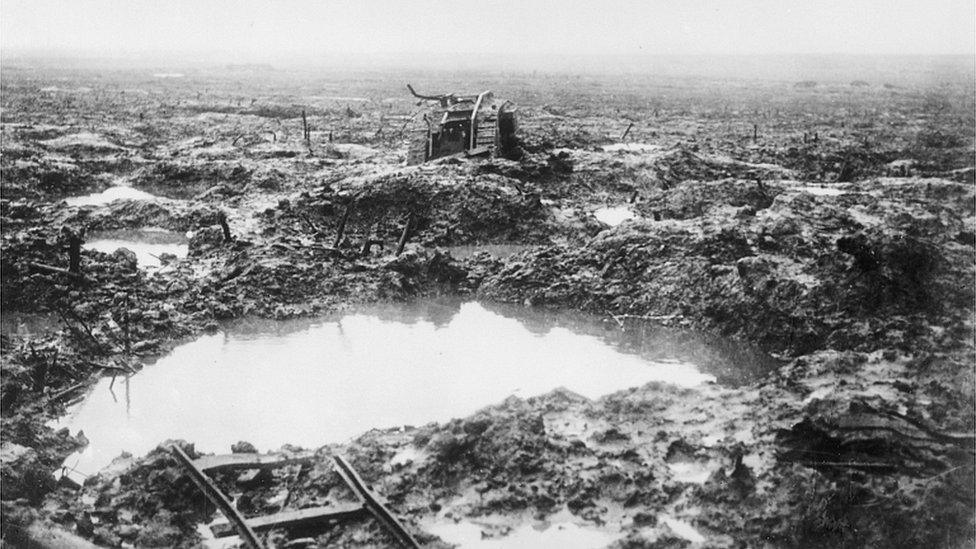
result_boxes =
[407,84,522,165]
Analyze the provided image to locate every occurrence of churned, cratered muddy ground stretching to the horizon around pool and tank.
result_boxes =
[0,62,976,547]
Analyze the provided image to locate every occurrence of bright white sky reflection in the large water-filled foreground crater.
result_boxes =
[59,299,776,480]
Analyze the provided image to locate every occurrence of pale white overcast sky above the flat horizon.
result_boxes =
[0,0,976,59]
